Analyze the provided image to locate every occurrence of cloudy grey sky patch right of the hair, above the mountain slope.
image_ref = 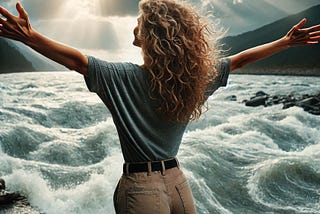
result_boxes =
[198,0,320,36]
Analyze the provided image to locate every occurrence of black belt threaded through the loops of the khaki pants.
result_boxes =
[123,158,179,173]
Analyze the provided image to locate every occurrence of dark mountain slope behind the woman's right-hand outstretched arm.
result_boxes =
[221,5,320,76]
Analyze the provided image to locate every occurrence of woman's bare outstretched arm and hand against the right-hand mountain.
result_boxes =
[229,19,320,70]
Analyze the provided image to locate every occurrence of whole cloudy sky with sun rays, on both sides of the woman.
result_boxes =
[0,0,320,61]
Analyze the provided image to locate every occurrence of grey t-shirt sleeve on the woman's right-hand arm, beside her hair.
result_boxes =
[206,58,231,96]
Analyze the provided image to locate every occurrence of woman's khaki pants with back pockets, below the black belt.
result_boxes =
[113,167,195,214]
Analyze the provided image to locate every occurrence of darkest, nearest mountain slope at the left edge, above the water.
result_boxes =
[0,38,34,74]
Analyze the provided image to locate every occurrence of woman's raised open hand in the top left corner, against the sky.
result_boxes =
[0,2,32,43]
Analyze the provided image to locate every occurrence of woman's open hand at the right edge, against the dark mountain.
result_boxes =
[283,18,320,47]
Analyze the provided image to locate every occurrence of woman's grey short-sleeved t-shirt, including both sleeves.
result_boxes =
[85,56,230,162]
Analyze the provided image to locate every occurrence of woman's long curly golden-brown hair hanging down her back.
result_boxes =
[137,0,219,123]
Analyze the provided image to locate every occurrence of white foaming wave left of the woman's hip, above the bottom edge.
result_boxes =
[0,147,122,214]
